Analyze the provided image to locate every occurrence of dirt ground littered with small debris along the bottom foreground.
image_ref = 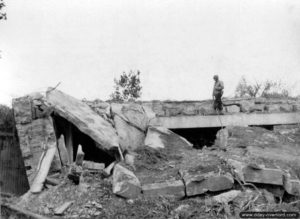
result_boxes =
[1,170,300,219]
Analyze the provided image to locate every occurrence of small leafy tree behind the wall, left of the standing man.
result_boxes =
[110,70,142,102]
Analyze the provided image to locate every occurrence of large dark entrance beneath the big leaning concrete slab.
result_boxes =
[52,114,115,166]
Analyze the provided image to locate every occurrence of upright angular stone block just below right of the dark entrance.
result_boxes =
[113,164,142,199]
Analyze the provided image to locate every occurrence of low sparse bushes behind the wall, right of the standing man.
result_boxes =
[235,76,290,98]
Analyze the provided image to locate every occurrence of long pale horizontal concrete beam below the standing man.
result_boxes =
[150,112,300,129]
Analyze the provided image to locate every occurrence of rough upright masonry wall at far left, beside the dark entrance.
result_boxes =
[13,96,55,184]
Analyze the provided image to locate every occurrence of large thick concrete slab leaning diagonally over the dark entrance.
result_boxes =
[47,89,119,151]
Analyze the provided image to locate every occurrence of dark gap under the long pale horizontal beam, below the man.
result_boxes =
[172,127,221,149]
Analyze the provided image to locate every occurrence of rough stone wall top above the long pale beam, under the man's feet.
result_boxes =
[85,98,300,117]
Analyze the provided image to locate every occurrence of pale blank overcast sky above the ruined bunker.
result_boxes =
[0,0,300,104]
